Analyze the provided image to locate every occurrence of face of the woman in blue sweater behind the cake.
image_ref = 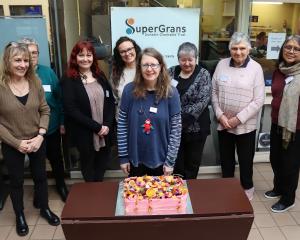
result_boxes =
[141,55,161,85]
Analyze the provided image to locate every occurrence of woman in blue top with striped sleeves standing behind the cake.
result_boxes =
[118,48,181,176]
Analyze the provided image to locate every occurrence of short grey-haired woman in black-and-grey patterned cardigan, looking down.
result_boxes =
[169,42,211,179]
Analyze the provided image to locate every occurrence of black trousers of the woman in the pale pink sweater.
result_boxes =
[218,130,256,189]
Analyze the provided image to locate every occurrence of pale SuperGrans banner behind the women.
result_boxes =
[111,7,200,67]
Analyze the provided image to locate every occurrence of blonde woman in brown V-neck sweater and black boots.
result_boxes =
[0,42,60,236]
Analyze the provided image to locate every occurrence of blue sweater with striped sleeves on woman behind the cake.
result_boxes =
[118,83,181,168]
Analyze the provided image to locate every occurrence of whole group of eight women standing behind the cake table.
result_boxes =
[0,32,300,236]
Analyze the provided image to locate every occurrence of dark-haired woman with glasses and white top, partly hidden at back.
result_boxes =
[110,37,141,120]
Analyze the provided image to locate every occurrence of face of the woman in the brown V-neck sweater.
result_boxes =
[10,54,29,78]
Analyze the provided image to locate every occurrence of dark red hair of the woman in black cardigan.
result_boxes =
[67,41,101,78]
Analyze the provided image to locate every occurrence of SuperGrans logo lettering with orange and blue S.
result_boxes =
[125,18,186,36]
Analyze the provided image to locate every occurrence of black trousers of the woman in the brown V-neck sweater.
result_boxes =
[2,142,48,213]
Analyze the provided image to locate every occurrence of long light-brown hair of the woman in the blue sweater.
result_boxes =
[133,48,172,100]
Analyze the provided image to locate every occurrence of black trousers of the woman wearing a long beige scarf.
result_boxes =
[270,124,300,205]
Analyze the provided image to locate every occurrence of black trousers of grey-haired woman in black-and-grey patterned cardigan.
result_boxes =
[174,133,207,179]
